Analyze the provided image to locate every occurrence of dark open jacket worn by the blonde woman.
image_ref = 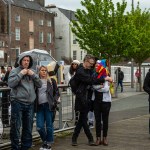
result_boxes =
[35,78,60,112]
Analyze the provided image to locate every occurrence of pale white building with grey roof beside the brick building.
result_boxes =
[46,5,86,62]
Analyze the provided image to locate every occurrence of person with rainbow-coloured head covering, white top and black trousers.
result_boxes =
[92,60,111,146]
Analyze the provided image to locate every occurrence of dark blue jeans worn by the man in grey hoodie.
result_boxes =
[10,101,34,150]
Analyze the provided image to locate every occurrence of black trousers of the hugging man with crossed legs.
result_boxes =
[72,111,93,141]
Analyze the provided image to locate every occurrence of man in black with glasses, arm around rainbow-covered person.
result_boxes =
[72,54,112,146]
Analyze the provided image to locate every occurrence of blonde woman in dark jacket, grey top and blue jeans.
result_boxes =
[36,66,60,150]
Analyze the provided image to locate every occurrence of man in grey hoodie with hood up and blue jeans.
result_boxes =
[8,53,42,150]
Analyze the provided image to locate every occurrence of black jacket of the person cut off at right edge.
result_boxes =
[143,72,150,101]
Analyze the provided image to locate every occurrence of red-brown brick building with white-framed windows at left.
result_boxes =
[0,0,55,65]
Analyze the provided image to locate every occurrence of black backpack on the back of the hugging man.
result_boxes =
[68,75,78,95]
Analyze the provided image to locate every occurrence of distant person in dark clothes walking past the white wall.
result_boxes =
[115,67,124,92]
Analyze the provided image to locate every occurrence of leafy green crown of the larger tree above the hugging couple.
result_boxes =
[72,0,128,62]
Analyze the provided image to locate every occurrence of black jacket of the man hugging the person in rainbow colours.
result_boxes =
[75,64,105,111]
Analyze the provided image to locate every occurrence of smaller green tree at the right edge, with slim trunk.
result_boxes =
[124,3,150,91]
